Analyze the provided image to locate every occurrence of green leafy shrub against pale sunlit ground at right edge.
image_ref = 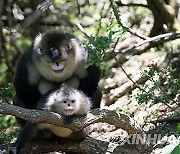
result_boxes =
[131,66,180,104]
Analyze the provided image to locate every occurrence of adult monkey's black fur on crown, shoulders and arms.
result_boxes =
[13,31,101,126]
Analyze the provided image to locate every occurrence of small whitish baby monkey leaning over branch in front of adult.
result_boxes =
[10,84,91,154]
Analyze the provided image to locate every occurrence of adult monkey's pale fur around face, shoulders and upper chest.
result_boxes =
[28,34,88,94]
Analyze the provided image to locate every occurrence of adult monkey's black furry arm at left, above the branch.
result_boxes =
[13,52,40,109]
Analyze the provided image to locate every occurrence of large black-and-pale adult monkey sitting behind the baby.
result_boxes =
[13,31,101,126]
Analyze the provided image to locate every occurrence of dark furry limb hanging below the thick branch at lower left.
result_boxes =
[10,122,37,154]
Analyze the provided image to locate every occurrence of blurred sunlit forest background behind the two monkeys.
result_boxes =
[0,0,180,153]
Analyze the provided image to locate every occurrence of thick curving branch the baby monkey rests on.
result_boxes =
[0,101,143,134]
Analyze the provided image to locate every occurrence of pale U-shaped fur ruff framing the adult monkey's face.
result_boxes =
[33,35,86,82]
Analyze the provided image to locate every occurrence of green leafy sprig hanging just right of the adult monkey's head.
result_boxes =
[85,21,125,72]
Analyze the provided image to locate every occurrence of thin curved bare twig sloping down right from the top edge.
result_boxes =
[109,0,149,40]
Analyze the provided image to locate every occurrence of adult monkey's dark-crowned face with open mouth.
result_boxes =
[33,31,79,77]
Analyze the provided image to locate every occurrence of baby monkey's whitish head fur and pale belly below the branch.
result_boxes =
[39,84,91,137]
